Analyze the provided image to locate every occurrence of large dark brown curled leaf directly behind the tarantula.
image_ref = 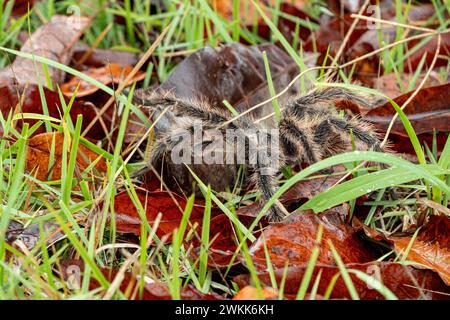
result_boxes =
[159,43,298,118]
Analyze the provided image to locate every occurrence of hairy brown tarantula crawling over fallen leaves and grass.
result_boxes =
[135,87,384,222]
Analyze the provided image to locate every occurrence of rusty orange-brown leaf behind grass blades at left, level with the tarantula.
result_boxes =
[25,132,107,181]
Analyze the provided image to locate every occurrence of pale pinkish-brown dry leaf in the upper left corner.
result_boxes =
[0,15,89,85]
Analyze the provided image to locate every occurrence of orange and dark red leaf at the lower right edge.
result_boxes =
[388,215,450,285]
